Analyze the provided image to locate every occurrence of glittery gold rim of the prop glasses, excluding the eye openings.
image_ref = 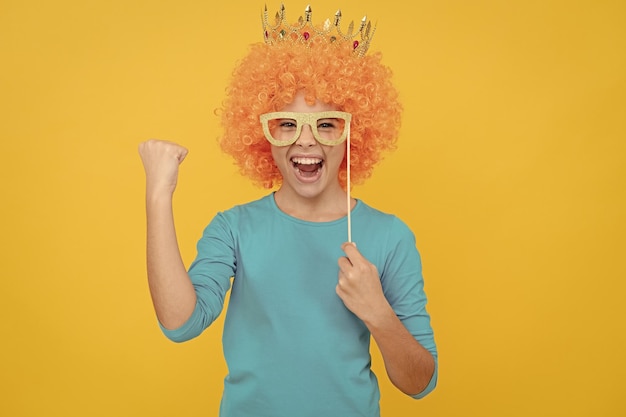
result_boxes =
[259,111,352,146]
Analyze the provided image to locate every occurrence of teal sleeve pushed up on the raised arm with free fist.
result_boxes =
[159,213,236,342]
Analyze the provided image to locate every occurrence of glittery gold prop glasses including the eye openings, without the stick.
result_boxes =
[260,111,352,146]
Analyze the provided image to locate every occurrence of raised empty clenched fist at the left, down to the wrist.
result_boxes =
[139,139,188,195]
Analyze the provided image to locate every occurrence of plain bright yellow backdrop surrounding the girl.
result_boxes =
[0,0,626,417]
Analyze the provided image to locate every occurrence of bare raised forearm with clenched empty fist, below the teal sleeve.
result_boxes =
[139,140,196,329]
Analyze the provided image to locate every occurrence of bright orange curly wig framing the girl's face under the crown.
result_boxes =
[220,37,402,188]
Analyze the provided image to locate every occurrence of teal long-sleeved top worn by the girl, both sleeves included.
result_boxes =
[162,194,437,417]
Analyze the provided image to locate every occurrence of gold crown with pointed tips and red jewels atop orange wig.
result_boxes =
[262,4,376,57]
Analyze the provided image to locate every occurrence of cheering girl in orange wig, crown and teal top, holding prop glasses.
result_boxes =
[139,4,437,417]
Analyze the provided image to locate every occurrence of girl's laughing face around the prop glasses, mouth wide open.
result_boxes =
[272,93,346,202]
